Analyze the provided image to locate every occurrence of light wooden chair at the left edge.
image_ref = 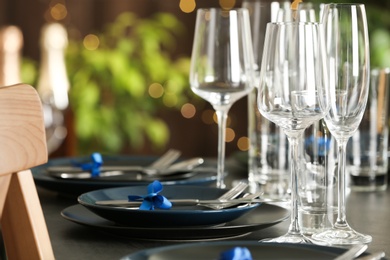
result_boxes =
[0,84,54,260]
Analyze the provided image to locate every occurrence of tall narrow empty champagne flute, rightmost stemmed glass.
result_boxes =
[312,4,372,245]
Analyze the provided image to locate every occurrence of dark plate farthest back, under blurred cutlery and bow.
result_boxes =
[32,156,216,196]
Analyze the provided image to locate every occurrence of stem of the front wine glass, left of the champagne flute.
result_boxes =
[288,132,303,234]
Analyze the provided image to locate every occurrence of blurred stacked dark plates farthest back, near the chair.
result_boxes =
[32,156,216,196]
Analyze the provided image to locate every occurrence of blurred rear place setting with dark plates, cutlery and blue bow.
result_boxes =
[32,149,216,197]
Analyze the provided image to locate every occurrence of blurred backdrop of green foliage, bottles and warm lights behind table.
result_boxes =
[0,0,390,157]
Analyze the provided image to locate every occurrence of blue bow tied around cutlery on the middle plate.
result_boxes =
[128,181,172,210]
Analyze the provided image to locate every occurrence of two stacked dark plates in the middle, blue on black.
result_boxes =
[62,185,289,241]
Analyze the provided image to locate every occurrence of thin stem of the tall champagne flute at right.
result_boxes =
[335,140,348,228]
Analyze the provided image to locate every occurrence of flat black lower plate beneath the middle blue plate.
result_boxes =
[61,203,290,241]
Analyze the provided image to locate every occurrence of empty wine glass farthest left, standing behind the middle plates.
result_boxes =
[190,8,254,188]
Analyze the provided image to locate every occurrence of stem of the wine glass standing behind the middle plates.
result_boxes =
[215,106,230,189]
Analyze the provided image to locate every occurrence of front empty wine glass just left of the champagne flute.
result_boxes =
[258,22,329,243]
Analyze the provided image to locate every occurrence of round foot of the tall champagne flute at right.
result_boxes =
[311,226,372,246]
